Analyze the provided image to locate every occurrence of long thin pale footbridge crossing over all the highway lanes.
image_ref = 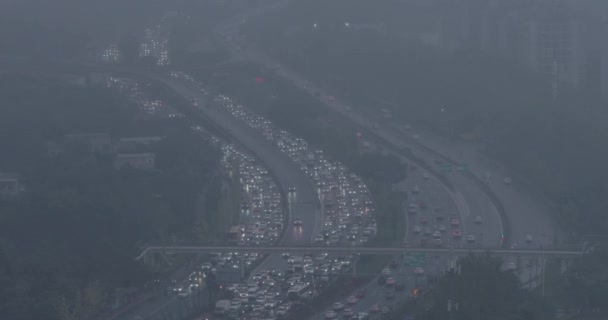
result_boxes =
[137,246,585,260]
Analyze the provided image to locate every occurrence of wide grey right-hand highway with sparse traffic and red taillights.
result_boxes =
[210,3,558,318]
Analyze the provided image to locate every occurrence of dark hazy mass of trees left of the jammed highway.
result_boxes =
[0,77,219,320]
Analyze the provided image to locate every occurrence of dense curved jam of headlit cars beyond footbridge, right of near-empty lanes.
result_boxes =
[215,95,377,246]
